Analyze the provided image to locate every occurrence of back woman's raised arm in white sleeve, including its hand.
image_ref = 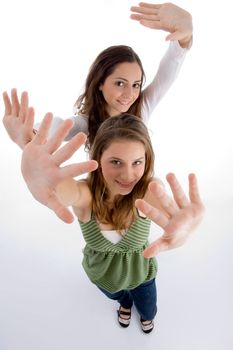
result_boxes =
[131,3,192,122]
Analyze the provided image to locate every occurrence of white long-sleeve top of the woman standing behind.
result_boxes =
[45,41,188,141]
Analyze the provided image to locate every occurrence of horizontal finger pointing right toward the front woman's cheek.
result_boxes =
[60,160,98,179]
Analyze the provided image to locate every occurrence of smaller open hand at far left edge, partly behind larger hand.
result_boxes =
[3,89,34,149]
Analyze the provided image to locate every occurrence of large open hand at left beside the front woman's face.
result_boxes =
[21,113,98,223]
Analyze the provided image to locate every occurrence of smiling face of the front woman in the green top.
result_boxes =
[100,140,145,199]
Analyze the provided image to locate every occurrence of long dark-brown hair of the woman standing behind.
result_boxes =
[75,45,145,148]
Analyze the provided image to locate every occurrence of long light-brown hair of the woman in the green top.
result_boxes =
[87,113,154,231]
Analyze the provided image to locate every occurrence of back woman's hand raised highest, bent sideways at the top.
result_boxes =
[130,2,193,47]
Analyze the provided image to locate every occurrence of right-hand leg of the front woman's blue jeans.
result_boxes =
[130,278,157,321]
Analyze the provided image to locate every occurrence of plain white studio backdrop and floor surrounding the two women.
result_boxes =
[0,0,233,350]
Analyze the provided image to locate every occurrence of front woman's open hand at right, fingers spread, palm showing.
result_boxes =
[135,173,204,258]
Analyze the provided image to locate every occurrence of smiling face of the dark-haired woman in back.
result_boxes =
[99,62,142,117]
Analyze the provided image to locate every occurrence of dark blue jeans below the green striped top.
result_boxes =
[99,278,157,321]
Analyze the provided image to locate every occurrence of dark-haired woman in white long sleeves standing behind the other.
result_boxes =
[3,3,192,149]
